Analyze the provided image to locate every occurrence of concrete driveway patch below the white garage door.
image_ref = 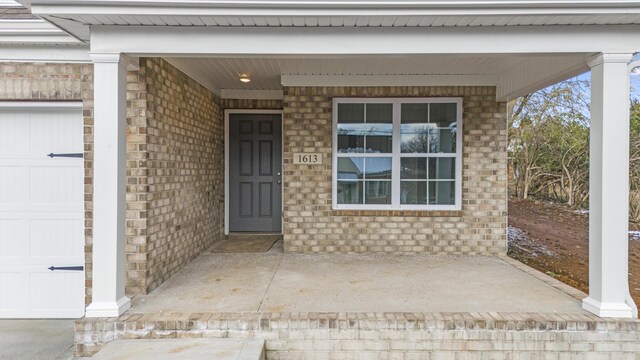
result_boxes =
[0,320,74,360]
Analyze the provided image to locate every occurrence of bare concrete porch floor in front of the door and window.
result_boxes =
[127,243,588,315]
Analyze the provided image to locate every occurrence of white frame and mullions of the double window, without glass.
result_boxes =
[331,97,464,211]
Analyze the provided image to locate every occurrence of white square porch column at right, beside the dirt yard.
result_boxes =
[582,53,637,317]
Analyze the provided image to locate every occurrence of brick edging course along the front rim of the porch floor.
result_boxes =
[76,312,640,332]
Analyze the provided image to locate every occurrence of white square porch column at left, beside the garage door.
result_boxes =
[86,53,131,317]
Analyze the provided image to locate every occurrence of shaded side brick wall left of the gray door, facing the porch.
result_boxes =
[140,58,224,291]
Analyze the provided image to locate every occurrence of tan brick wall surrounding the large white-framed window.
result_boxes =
[283,87,507,254]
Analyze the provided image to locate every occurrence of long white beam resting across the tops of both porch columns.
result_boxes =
[91,25,640,57]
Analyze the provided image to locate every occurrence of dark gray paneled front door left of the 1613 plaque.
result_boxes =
[228,114,282,232]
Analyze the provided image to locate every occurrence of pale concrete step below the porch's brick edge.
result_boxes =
[92,338,265,360]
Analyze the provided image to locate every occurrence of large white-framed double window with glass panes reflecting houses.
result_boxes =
[333,98,462,210]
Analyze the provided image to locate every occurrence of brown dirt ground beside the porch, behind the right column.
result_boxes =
[509,198,640,304]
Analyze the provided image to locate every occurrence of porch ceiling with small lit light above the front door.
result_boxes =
[166,54,589,97]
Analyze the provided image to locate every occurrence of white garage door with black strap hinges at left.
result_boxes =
[0,103,84,318]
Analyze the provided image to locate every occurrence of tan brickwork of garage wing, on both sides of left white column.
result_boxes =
[0,59,224,304]
